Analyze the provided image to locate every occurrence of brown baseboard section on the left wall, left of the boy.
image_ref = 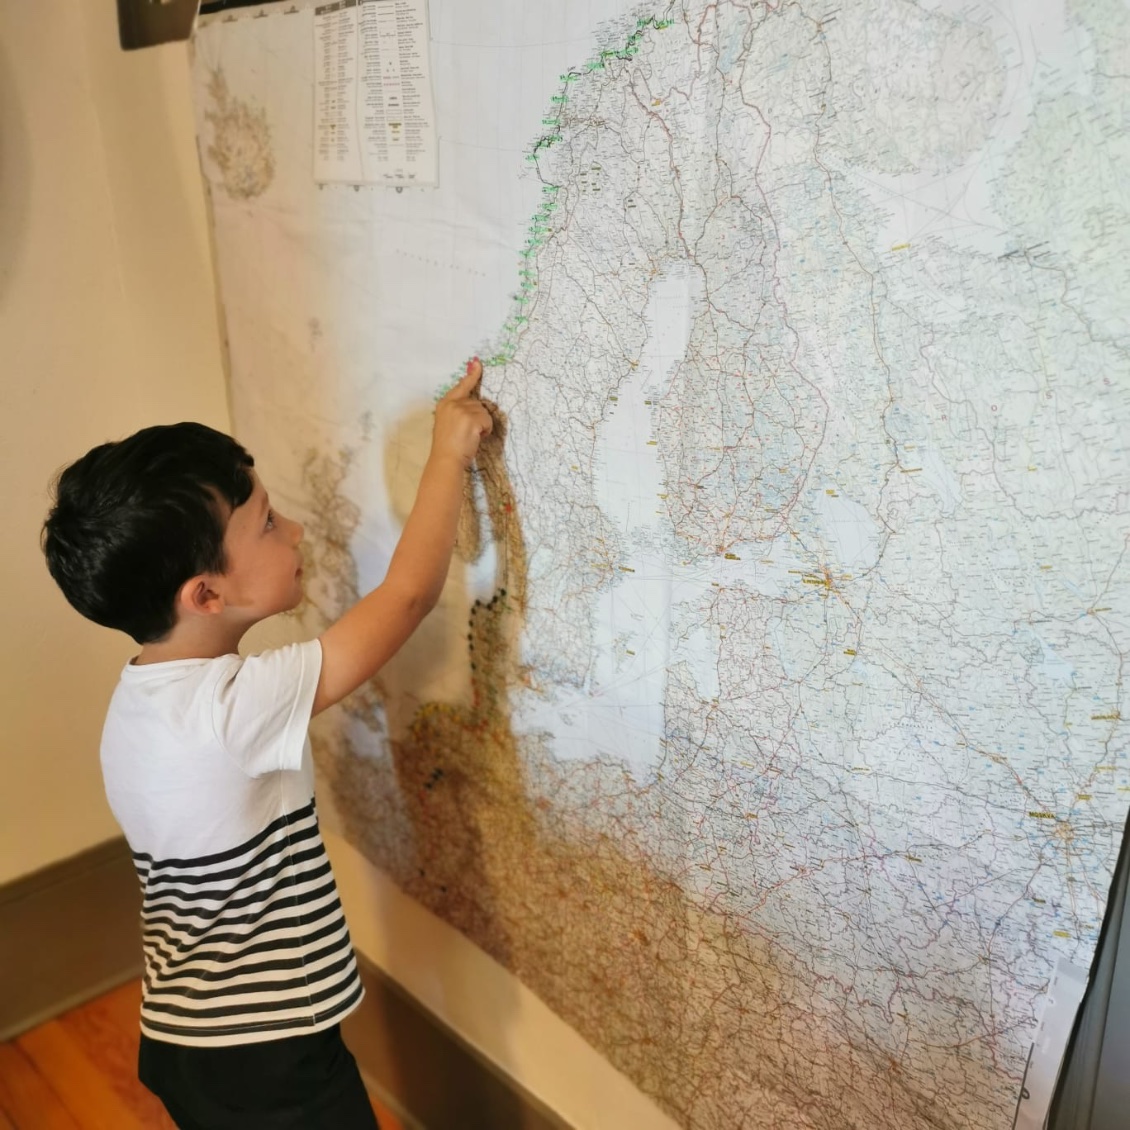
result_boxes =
[0,837,141,1041]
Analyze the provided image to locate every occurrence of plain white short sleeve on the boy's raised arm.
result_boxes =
[212,640,322,777]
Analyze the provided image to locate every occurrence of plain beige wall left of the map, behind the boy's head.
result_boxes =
[0,0,228,883]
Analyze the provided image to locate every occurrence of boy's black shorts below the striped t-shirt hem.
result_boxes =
[138,1025,379,1130]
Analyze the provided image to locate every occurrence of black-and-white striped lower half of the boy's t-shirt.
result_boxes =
[133,800,362,1044]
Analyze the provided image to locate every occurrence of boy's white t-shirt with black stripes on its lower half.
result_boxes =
[102,640,362,1046]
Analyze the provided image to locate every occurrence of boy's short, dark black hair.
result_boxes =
[43,424,254,644]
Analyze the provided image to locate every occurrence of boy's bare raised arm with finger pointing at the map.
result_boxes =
[313,358,492,714]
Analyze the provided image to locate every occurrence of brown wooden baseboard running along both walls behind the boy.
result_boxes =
[0,838,568,1130]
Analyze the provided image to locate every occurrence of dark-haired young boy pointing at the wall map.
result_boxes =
[44,358,492,1130]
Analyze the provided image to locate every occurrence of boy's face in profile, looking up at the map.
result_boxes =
[214,470,303,625]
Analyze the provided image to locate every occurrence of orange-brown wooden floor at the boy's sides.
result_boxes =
[0,981,403,1130]
